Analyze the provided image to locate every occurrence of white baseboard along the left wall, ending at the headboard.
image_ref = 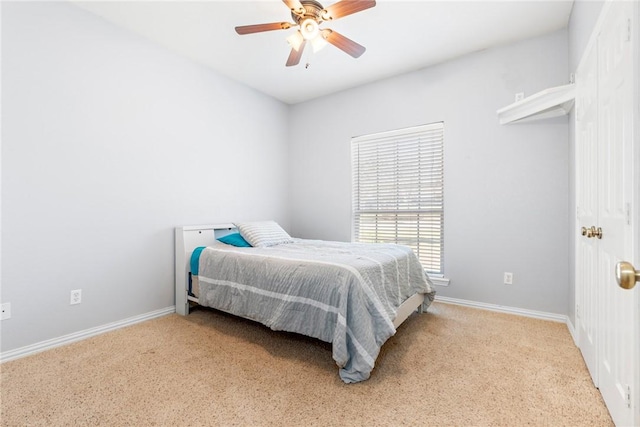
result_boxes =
[0,306,176,363]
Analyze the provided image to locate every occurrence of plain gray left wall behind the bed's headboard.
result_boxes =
[1,2,289,351]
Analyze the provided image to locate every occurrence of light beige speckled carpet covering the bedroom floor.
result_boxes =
[0,303,612,426]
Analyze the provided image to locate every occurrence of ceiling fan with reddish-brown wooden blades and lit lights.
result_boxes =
[236,0,376,67]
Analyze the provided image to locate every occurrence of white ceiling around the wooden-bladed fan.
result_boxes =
[74,0,573,104]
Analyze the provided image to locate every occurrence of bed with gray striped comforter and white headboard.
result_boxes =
[175,223,435,383]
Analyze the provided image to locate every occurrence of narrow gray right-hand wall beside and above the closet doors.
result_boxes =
[568,0,604,326]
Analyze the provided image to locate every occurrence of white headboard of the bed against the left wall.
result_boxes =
[175,223,237,316]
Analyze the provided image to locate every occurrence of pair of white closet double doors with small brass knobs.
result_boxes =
[576,1,640,426]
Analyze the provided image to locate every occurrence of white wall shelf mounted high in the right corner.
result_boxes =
[497,84,576,125]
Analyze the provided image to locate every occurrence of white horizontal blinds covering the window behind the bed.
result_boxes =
[351,123,444,274]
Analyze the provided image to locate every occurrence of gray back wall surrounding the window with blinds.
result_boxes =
[290,30,569,314]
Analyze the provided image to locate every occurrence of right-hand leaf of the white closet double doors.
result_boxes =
[597,1,640,426]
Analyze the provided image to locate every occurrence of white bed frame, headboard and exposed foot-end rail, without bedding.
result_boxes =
[175,223,424,328]
